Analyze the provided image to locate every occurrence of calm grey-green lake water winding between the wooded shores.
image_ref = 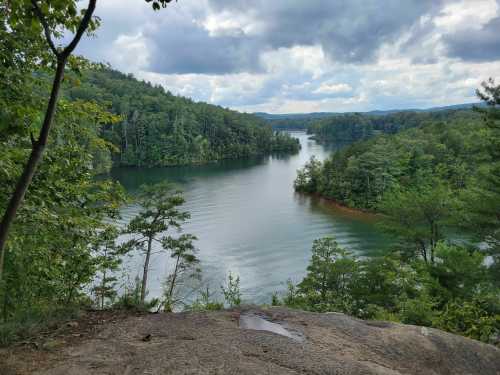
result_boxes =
[112,132,389,303]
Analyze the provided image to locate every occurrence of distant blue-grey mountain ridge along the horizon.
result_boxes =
[253,103,484,120]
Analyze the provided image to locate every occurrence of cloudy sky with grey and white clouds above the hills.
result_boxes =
[74,0,500,113]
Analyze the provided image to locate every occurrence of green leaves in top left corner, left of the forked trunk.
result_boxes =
[0,0,99,139]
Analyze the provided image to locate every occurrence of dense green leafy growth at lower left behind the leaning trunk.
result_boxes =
[0,102,124,320]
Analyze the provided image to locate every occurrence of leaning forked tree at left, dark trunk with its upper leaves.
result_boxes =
[0,0,180,281]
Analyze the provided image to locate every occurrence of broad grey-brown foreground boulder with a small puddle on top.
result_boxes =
[0,307,500,375]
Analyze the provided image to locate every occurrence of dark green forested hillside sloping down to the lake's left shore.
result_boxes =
[66,68,299,167]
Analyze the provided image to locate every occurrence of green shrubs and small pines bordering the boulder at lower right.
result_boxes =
[282,237,500,342]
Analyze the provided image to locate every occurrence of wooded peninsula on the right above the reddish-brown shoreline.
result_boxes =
[296,111,491,210]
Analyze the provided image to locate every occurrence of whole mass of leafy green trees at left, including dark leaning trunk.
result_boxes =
[0,0,127,335]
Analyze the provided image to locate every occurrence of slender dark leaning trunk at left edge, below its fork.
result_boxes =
[0,57,67,281]
